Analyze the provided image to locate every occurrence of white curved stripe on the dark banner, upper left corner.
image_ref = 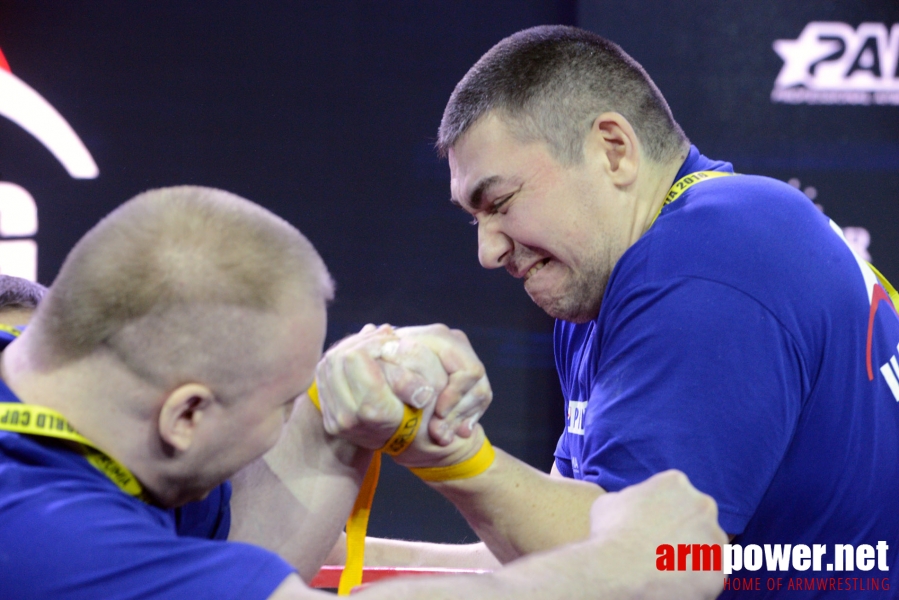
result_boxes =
[0,69,100,179]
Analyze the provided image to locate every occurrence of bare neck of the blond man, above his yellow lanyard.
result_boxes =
[0,329,178,505]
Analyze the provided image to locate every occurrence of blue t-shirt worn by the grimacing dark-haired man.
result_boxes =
[554,148,899,598]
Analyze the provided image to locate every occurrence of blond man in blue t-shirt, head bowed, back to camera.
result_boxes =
[0,187,724,600]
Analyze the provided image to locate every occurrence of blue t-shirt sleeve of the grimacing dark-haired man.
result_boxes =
[584,277,807,534]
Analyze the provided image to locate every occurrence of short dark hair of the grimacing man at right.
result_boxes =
[437,25,689,164]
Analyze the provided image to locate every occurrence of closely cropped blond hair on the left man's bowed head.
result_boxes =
[33,186,333,394]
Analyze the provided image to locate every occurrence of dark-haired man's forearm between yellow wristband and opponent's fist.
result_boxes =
[430,449,603,563]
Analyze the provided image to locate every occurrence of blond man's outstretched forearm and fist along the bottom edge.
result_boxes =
[272,472,727,600]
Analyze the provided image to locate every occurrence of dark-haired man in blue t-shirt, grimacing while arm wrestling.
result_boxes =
[318,26,899,598]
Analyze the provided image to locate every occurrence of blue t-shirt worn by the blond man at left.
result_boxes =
[0,336,294,600]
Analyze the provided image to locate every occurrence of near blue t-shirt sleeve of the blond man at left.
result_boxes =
[0,479,294,600]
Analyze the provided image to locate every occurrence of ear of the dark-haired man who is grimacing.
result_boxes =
[585,112,640,187]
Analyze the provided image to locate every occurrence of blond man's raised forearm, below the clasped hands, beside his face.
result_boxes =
[229,398,371,581]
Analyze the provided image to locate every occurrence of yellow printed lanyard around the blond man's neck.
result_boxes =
[0,402,149,502]
